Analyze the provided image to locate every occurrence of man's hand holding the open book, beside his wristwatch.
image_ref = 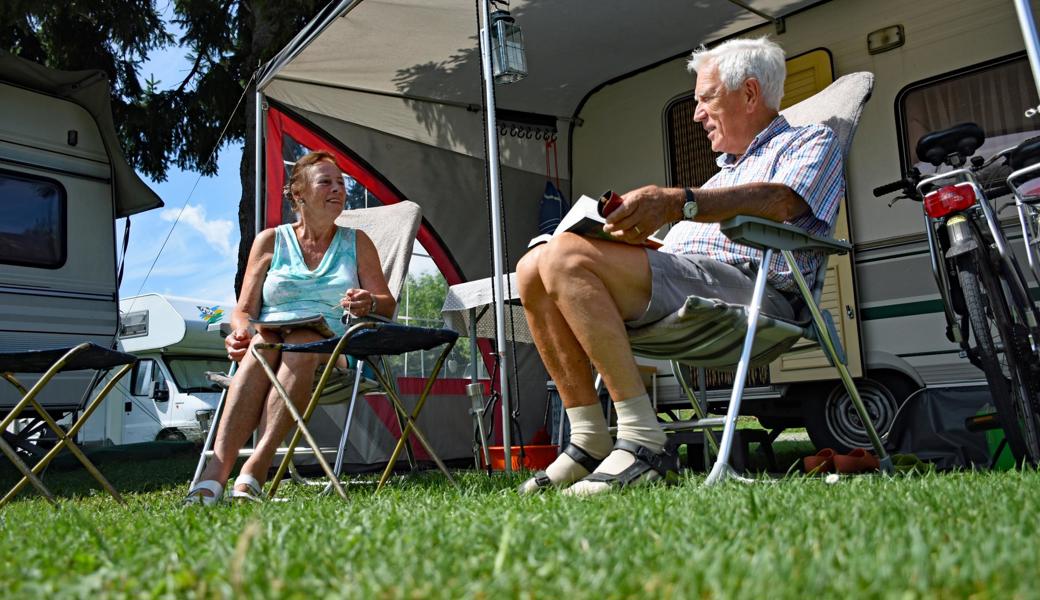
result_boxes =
[603,185,684,243]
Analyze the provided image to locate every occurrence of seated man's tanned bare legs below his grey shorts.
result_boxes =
[517,234,666,491]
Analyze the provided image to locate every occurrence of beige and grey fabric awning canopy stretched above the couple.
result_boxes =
[260,0,820,283]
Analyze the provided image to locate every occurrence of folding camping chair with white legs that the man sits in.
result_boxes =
[629,73,892,485]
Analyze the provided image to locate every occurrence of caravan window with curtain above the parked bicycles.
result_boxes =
[895,55,1040,173]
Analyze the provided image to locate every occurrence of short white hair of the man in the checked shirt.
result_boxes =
[686,37,787,110]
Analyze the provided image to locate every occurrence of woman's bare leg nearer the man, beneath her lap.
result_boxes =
[236,330,326,491]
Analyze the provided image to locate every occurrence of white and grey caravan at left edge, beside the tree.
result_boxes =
[0,51,162,448]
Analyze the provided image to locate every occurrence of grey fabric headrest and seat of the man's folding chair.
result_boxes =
[628,72,874,370]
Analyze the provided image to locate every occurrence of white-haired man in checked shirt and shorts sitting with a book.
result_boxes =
[517,38,844,494]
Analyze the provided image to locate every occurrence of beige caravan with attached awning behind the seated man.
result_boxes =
[251,0,1040,448]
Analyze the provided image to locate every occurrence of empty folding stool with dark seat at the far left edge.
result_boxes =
[0,342,137,506]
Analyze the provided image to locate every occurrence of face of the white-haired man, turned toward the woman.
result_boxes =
[694,64,758,156]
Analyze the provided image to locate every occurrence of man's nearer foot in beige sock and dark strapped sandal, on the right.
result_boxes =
[563,438,679,496]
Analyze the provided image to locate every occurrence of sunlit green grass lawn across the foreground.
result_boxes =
[0,445,1040,599]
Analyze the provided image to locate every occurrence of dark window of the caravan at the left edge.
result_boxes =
[0,171,67,268]
